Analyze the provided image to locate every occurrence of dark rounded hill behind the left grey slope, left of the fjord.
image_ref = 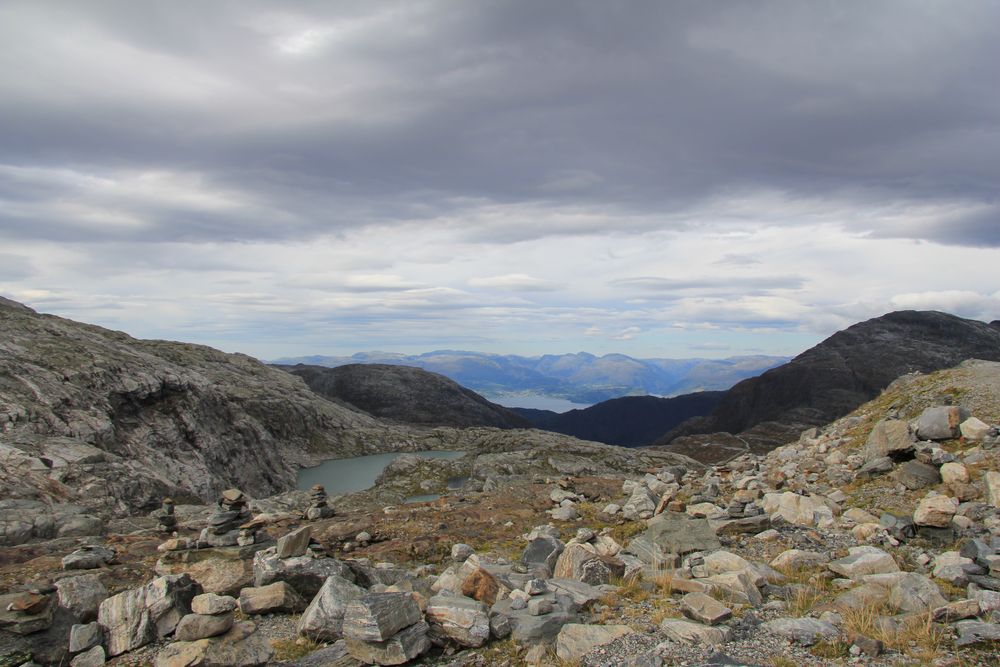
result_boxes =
[276,364,530,428]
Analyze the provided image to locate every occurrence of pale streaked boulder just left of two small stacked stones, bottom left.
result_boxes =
[97,574,201,657]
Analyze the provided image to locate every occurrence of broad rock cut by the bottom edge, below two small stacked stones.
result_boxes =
[154,621,274,667]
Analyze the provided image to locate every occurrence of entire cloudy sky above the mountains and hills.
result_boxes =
[0,0,1000,358]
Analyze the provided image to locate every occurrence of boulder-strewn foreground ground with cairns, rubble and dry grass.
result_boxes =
[0,361,1000,667]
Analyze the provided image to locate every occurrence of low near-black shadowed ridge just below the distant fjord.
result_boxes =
[513,391,723,447]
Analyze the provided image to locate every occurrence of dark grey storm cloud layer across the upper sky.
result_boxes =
[0,0,1000,246]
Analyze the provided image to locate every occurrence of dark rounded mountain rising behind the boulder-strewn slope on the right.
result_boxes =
[655,311,1000,453]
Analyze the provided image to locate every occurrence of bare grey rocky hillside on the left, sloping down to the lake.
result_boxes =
[0,301,420,511]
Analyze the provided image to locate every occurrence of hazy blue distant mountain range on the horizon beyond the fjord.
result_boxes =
[270,350,788,403]
